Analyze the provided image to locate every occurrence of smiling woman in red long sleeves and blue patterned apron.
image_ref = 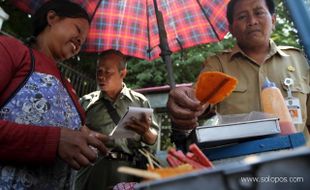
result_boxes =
[0,0,106,189]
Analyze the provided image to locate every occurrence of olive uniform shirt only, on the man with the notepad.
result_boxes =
[80,84,159,154]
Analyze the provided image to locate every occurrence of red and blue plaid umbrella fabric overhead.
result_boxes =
[12,0,229,60]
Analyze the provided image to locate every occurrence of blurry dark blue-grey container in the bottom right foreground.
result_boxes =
[135,147,310,190]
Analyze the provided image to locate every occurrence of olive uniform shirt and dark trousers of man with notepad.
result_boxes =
[74,84,159,190]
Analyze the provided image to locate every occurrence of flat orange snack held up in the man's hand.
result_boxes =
[196,71,238,104]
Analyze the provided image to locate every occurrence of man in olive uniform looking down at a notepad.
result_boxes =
[75,50,159,190]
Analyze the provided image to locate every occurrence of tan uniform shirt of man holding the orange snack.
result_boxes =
[203,40,310,136]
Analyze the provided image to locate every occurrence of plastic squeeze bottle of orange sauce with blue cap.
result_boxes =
[261,78,296,135]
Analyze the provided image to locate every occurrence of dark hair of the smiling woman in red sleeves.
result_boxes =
[33,0,90,37]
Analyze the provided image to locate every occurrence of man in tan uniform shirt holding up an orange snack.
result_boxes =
[167,0,310,147]
